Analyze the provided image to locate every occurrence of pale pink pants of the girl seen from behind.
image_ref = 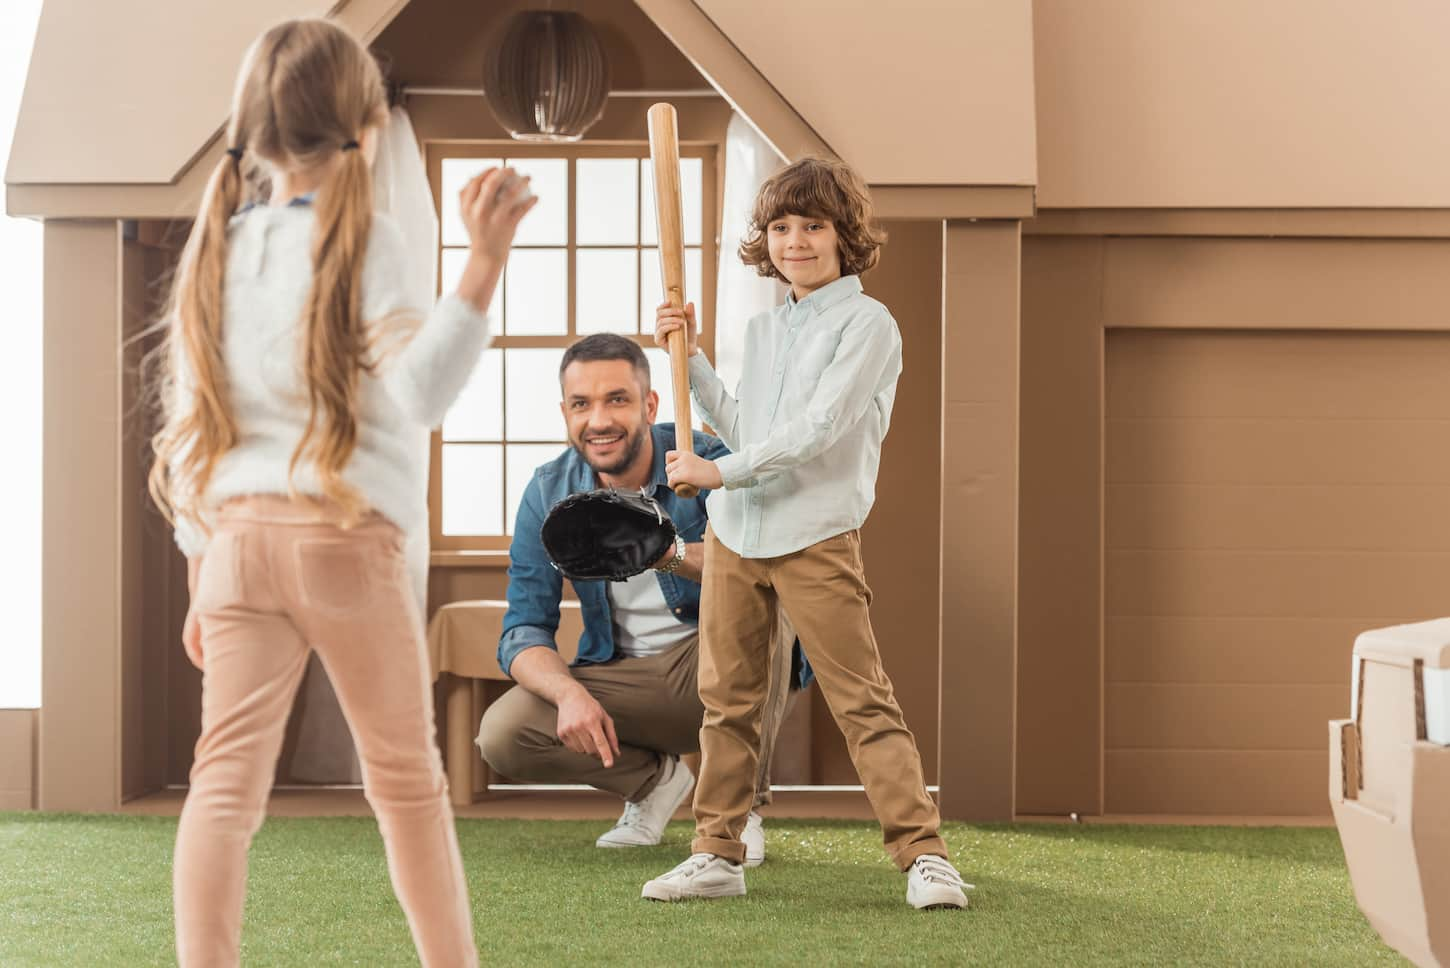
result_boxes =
[173,497,477,968]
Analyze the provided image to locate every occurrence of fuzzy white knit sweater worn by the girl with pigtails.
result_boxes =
[175,201,492,556]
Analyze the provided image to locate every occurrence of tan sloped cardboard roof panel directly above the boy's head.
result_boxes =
[696,0,1037,185]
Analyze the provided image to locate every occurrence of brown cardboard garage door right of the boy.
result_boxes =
[1105,330,1450,814]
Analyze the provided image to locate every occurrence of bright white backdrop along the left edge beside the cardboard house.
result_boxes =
[0,0,41,709]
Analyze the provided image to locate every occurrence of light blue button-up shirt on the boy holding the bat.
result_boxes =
[690,275,902,558]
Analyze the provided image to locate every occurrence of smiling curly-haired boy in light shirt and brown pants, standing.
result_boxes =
[644,158,967,909]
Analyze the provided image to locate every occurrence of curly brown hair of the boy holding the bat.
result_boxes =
[740,158,886,283]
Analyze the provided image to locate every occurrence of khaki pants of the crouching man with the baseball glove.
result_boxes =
[479,619,795,809]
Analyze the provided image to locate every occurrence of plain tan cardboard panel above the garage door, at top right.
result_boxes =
[1032,0,1450,210]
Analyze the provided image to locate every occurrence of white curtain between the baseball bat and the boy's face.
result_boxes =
[715,113,786,387]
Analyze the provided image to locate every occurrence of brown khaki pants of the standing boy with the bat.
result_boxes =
[692,530,947,871]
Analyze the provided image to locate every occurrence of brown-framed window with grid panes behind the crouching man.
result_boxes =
[428,142,716,551]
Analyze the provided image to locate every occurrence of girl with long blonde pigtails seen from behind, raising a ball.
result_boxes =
[149,20,534,967]
